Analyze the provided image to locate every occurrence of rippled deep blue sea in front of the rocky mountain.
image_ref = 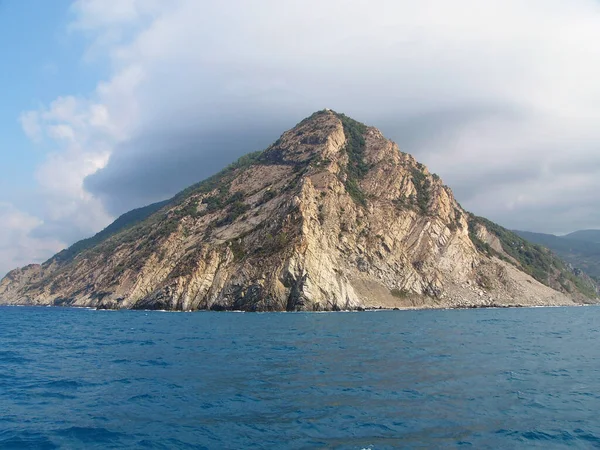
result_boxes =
[0,307,600,450]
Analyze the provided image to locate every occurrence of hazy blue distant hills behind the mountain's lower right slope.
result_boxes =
[515,230,600,281]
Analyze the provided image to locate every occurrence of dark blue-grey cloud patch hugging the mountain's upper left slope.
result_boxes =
[85,119,292,216]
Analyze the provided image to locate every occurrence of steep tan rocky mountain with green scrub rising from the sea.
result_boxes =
[0,110,596,311]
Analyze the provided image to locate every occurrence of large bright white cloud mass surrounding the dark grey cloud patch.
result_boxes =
[9,0,600,274]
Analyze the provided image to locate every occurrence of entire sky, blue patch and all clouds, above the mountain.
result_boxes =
[0,0,600,276]
